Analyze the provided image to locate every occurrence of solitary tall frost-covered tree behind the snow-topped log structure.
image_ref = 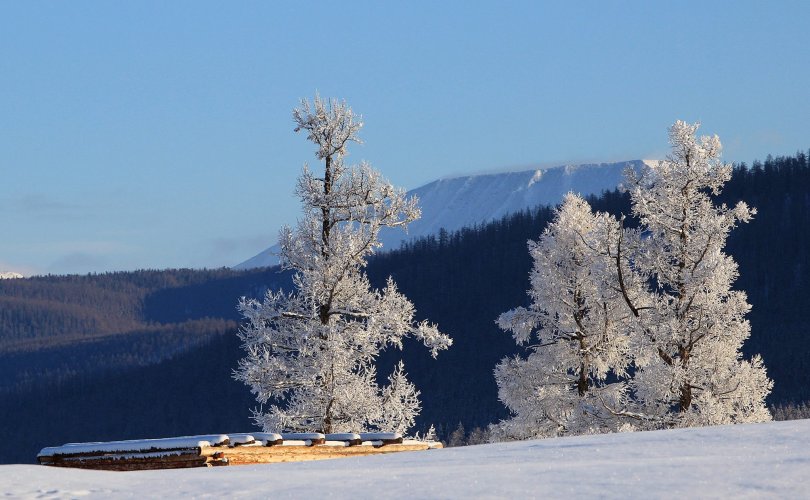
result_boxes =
[235,96,452,433]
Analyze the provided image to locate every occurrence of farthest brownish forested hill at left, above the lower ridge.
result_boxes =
[0,269,288,352]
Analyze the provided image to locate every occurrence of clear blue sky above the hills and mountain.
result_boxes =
[0,0,810,274]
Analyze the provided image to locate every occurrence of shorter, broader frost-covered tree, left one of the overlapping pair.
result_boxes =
[492,194,637,439]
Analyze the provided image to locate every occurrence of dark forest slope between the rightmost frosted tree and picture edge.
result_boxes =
[719,152,810,405]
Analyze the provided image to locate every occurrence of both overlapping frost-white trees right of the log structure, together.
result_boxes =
[493,121,772,439]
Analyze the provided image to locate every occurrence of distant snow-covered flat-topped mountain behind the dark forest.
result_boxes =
[234,160,645,269]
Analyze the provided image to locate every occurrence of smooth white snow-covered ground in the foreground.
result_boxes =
[0,420,810,498]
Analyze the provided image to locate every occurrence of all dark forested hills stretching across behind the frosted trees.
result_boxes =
[0,152,810,463]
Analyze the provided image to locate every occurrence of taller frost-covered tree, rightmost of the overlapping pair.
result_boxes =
[628,121,772,426]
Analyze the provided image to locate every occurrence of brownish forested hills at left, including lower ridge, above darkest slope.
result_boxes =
[0,269,289,393]
